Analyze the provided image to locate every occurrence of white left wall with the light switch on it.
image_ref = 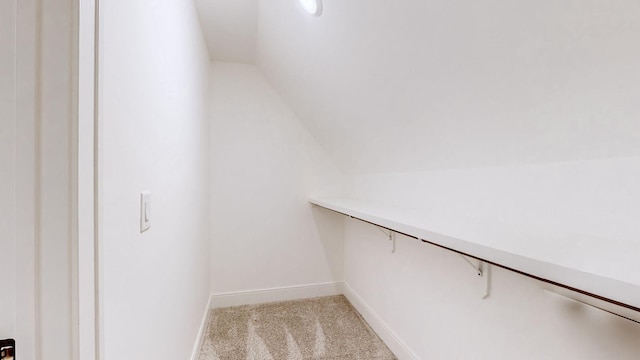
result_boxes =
[99,0,210,359]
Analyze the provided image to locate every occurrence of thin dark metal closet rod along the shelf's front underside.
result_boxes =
[325,208,640,316]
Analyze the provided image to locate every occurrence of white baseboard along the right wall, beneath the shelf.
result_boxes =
[342,283,419,360]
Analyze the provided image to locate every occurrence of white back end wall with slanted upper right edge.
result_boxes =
[211,62,343,293]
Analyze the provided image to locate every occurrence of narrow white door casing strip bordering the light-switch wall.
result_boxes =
[73,0,104,360]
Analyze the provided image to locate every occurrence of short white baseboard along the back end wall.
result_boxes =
[211,281,343,308]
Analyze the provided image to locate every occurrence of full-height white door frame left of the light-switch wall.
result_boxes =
[15,0,103,360]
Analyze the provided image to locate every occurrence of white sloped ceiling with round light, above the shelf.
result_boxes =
[199,0,640,173]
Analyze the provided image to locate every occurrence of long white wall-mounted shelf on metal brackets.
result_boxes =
[310,198,640,319]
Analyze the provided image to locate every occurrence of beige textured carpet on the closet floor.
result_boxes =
[198,295,396,360]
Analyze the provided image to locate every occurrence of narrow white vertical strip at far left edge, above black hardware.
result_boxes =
[0,1,17,339]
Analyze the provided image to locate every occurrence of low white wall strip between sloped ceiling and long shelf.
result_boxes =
[349,157,640,262]
